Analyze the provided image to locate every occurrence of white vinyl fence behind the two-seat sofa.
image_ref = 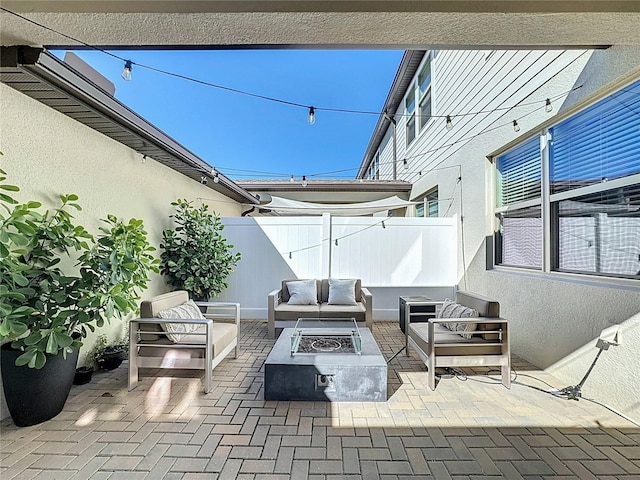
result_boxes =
[218,214,458,319]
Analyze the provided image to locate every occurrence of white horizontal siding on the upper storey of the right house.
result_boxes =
[397,50,583,188]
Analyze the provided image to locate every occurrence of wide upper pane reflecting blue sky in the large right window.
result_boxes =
[550,81,640,193]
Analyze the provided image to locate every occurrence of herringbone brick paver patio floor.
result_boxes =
[0,321,640,480]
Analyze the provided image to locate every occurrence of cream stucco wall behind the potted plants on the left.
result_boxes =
[0,84,242,418]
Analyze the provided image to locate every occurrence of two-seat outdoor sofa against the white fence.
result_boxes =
[267,278,373,338]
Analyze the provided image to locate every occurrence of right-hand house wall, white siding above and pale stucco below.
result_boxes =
[372,46,640,419]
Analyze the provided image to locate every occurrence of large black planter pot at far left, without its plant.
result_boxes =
[0,343,78,427]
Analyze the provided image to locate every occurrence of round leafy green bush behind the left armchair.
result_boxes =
[160,199,241,300]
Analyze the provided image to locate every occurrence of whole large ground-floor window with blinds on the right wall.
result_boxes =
[495,76,640,279]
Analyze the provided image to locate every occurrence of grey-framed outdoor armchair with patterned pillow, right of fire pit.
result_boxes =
[405,291,511,390]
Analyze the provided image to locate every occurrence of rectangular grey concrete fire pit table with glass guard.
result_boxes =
[264,318,387,402]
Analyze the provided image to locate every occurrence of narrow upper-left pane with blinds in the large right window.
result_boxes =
[496,137,542,207]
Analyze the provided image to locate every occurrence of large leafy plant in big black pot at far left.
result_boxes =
[0,170,159,426]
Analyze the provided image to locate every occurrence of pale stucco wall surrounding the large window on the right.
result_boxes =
[460,47,640,420]
